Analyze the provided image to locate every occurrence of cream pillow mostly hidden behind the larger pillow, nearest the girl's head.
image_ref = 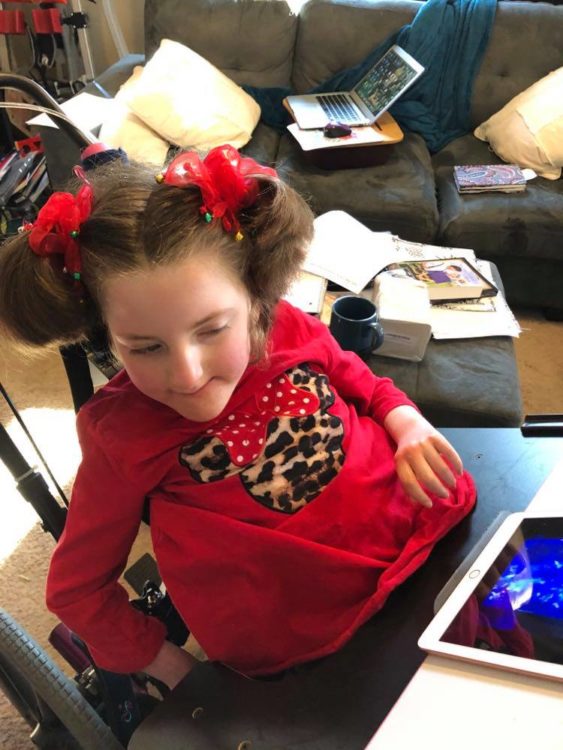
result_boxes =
[99,66,170,167]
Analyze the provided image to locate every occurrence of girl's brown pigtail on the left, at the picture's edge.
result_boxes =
[0,232,88,346]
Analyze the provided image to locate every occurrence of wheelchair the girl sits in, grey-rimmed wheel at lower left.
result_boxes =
[0,73,182,750]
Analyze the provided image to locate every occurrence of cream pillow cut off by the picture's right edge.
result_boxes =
[474,68,563,180]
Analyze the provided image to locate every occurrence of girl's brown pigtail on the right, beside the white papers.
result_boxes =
[241,178,313,328]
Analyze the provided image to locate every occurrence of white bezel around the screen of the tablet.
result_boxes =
[418,509,563,681]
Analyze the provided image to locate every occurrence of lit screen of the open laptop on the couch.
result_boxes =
[354,47,423,116]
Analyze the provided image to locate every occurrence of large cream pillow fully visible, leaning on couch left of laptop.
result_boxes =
[124,39,260,151]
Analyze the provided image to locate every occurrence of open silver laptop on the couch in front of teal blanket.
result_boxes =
[286,44,424,130]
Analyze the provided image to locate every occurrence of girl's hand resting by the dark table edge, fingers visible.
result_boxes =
[384,406,463,508]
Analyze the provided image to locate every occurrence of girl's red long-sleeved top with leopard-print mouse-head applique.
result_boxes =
[47,302,475,675]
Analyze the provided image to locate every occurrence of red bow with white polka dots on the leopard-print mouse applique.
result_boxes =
[200,373,320,466]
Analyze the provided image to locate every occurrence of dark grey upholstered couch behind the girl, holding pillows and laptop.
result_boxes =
[93,0,563,317]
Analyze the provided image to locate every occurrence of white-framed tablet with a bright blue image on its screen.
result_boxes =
[418,511,563,681]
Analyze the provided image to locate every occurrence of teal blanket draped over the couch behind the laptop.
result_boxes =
[243,0,496,153]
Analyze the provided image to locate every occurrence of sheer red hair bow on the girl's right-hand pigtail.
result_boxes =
[157,145,277,239]
